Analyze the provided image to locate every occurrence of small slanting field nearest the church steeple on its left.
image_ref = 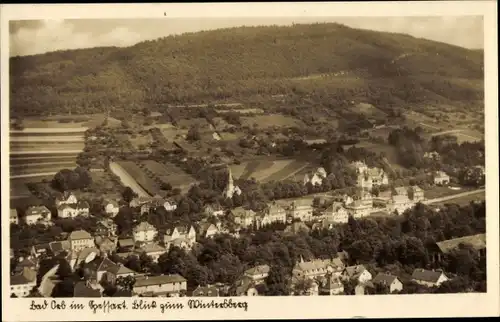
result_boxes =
[140,160,196,192]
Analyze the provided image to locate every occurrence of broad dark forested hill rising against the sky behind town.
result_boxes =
[10,23,483,115]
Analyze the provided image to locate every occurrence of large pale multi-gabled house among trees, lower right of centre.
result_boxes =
[292,257,345,279]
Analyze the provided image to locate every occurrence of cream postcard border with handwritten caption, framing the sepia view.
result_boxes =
[0,1,500,321]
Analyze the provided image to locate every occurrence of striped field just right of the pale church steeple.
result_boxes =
[230,159,309,183]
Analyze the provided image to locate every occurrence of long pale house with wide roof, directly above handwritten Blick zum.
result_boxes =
[132,274,187,297]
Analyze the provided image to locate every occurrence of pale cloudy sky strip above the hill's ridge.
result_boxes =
[9,16,484,56]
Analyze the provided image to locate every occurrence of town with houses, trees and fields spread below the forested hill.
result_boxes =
[10,22,486,298]
